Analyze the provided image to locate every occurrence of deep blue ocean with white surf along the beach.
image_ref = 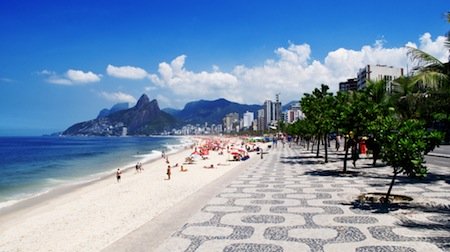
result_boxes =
[0,136,191,208]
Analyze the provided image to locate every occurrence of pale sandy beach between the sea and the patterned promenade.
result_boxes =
[0,137,256,251]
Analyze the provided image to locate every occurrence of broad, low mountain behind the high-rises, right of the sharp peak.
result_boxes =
[175,98,261,124]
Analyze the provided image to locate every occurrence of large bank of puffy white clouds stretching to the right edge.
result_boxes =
[149,33,449,104]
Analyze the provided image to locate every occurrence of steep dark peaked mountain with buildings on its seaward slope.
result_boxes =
[63,94,177,136]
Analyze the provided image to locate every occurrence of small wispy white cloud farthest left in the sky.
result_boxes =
[40,69,102,86]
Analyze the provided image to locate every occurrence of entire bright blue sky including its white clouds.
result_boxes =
[0,0,450,135]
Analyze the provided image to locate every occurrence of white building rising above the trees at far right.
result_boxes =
[357,65,403,92]
